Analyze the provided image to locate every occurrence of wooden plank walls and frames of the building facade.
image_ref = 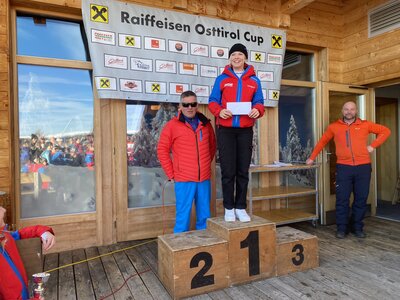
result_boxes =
[0,0,400,251]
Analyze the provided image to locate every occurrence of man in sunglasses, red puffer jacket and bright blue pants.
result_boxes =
[157,91,216,233]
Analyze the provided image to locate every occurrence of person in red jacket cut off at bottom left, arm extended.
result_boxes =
[0,206,55,300]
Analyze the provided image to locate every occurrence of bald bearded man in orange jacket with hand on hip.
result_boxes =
[306,101,390,239]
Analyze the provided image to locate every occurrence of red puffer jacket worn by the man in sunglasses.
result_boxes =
[157,113,216,182]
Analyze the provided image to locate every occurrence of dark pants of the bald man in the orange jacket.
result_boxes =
[336,164,371,232]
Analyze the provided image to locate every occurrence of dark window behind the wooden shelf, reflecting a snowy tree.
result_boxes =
[278,50,315,186]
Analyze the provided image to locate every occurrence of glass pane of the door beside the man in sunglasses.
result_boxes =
[126,101,178,208]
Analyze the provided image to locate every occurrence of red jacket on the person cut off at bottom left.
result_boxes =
[0,225,54,300]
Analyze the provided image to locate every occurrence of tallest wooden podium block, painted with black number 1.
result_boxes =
[207,216,276,285]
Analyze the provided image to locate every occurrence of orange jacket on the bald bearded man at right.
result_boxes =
[310,119,390,166]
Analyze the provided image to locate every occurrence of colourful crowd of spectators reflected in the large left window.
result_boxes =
[20,134,94,173]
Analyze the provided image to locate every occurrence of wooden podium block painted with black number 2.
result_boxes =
[158,230,229,299]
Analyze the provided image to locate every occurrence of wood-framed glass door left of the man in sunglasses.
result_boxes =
[112,100,178,241]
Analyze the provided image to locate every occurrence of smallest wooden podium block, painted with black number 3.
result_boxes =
[276,226,319,276]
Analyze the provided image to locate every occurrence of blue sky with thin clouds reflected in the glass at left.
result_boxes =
[17,16,150,138]
